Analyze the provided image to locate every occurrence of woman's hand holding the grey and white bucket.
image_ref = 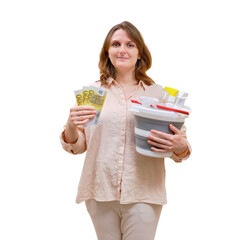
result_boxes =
[147,124,187,155]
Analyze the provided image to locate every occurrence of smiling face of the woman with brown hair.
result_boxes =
[108,29,140,72]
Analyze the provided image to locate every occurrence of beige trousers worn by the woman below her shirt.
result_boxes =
[86,199,162,240]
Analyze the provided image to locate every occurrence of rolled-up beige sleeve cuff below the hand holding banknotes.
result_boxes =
[60,127,87,154]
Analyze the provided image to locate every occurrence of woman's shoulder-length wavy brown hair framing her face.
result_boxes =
[98,21,154,85]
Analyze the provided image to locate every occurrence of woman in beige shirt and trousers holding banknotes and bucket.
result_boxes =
[61,22,190,240]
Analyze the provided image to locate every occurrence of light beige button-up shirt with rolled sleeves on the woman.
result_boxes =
[60,78,190,205]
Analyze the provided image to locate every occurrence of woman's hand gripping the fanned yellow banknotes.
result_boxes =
[67,106,97,128]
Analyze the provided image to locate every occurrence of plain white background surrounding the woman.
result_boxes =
[0,0,240,240]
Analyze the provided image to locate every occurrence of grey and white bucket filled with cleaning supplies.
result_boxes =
[129,88,190,158]
